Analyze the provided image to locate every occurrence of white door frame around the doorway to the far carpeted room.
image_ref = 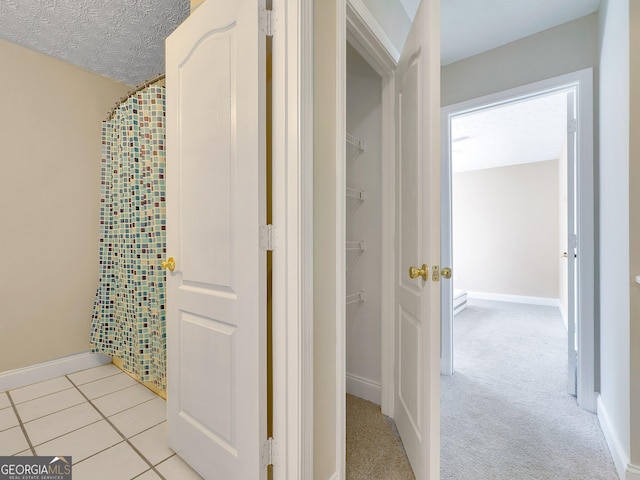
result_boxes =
[441,68,597,412]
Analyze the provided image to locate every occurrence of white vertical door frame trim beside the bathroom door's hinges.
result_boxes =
[271,0,314,480]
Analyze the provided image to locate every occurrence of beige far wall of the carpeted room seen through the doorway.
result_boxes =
[453,160,559,299]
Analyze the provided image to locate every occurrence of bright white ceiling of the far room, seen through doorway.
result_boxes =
[451,93,567,172]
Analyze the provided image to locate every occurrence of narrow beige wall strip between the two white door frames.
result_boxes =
[313,0,345,480]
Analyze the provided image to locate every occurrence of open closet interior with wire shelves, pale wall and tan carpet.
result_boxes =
[345,40,413,479]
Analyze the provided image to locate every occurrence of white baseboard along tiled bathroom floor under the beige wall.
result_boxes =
[0,352,111,392]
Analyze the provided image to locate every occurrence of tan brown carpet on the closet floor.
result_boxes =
[347,395,415,480]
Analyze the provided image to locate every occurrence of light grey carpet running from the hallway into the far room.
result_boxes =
[440,298,618,480]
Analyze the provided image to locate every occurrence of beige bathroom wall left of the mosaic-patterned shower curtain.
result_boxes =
[0,41,128,372]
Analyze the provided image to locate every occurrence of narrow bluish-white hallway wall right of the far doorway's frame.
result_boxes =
[599,0,631,478]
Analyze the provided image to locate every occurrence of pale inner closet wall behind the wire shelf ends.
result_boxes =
[346,46,382,404]
